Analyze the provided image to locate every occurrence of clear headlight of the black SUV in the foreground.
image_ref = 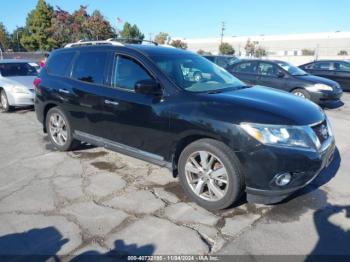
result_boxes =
[241,123,321,150]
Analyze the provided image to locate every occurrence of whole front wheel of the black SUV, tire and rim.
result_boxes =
[178,139,244,210]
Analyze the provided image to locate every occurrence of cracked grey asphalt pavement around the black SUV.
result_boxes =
[0,93,350,260]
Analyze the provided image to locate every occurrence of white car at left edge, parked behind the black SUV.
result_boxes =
[0,59,38,112]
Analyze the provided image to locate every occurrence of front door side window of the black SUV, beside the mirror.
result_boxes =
[112,55,152,90]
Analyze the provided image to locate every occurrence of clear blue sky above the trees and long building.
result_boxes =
[0,0,350,38]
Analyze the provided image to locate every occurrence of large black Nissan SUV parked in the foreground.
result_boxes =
[35,42,335,209]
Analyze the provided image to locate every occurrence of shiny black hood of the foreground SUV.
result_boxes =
[207,86,325,125]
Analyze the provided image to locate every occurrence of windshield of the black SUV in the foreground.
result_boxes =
[151,54,244,92]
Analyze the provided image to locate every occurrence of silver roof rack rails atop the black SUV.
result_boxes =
[64,38,158,48]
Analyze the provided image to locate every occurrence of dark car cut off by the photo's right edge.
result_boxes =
[299,60,350,91]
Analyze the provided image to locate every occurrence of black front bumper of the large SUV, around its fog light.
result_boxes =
[239,137,335,204]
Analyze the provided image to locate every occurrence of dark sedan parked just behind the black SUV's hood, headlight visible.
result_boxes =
[228,59,343,104]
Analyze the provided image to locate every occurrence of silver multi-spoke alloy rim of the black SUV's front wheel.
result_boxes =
[185,151,229,201]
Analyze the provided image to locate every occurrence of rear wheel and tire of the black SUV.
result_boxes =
[45,107,80,151]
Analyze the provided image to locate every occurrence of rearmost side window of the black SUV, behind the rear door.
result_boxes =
[45,52,75,76]
